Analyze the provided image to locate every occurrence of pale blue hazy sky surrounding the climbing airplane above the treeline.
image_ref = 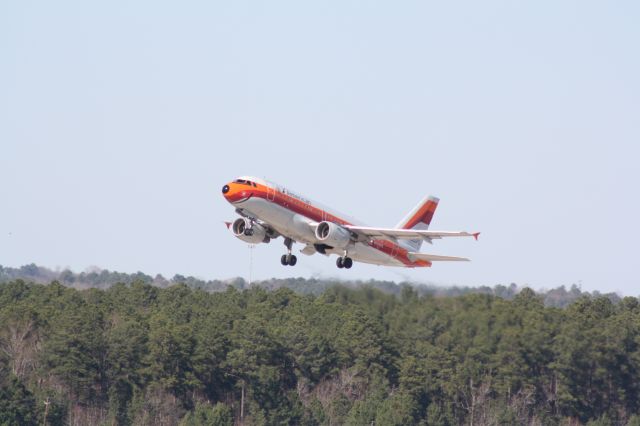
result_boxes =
[0,0,640,295]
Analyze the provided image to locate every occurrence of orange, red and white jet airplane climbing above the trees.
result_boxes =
[222,176,480,269]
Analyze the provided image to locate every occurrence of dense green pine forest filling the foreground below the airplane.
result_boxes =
[0,278,640,425]
